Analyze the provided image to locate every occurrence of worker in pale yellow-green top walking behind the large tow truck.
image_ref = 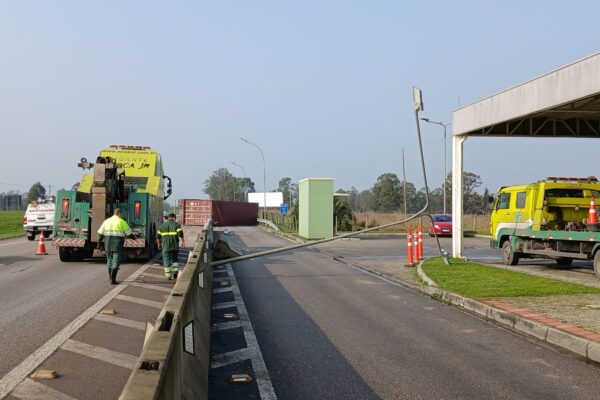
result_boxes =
[98,208,135,285]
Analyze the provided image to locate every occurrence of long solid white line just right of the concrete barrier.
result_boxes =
[227,264,277,400]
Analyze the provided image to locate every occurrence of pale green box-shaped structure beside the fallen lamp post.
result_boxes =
[298,178,333,239]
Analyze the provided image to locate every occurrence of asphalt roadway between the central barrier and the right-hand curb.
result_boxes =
[233,228,600,399]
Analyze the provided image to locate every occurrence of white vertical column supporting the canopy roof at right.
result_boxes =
[452,135,467,258]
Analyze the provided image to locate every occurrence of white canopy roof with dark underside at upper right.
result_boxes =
[452,53,600,137]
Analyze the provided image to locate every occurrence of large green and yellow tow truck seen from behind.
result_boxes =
[52,145,172,262]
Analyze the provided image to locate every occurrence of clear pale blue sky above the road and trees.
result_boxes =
[0,0,600,198]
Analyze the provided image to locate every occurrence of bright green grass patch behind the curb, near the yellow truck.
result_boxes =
[423,258,600,298]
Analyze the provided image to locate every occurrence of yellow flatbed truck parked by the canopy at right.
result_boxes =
[490,177,600,278]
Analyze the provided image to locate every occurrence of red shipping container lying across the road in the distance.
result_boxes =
[179,199,258,226]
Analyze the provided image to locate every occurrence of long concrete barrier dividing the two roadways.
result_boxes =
[119,222,213,400]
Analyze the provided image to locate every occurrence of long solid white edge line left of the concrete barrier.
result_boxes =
[0,257,157,399]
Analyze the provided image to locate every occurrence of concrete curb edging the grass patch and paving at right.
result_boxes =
[416,262,600,363]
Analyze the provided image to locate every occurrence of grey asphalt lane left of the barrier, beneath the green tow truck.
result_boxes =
[0,238,149,377]
